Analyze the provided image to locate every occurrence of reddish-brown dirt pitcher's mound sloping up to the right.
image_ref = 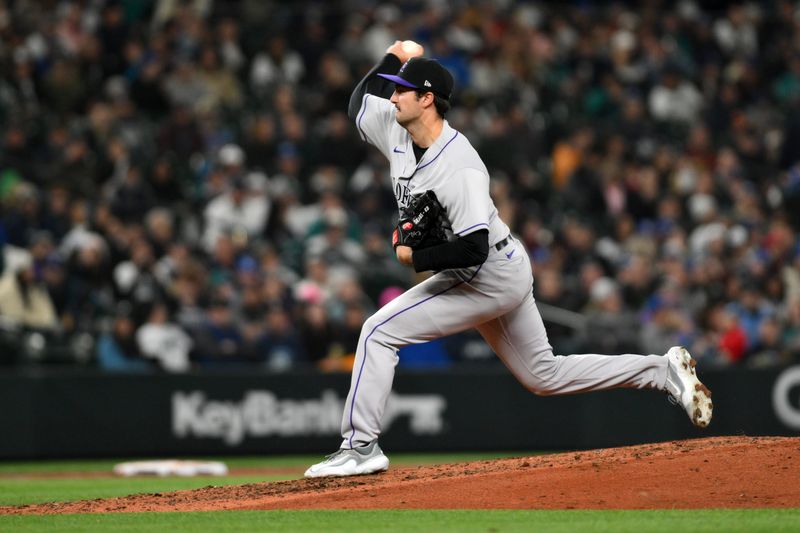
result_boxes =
[0,437,800,514]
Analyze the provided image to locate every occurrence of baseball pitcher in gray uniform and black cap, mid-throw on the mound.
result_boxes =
[305,41,712,477]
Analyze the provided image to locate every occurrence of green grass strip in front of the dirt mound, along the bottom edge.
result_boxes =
[0,509,800,533]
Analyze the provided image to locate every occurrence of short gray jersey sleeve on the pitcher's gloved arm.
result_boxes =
[434,168,493,237]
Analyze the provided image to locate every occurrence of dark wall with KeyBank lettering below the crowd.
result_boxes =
[0,366,800,459]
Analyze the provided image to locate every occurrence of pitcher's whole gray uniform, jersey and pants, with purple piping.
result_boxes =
[341,94,667,448]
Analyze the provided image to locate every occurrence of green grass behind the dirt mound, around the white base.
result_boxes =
[0,453,530,505]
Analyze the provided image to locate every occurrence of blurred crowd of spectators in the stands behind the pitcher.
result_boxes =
[0,0,800,372]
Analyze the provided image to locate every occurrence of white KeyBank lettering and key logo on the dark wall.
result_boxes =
[172,390,447,446]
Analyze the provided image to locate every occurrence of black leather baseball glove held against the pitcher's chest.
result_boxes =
[392,191,449,250]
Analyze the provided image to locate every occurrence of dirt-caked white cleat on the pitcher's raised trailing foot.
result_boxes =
[664,346,714,428]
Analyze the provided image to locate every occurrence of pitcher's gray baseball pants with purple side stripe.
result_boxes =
[341,235,667,448]
